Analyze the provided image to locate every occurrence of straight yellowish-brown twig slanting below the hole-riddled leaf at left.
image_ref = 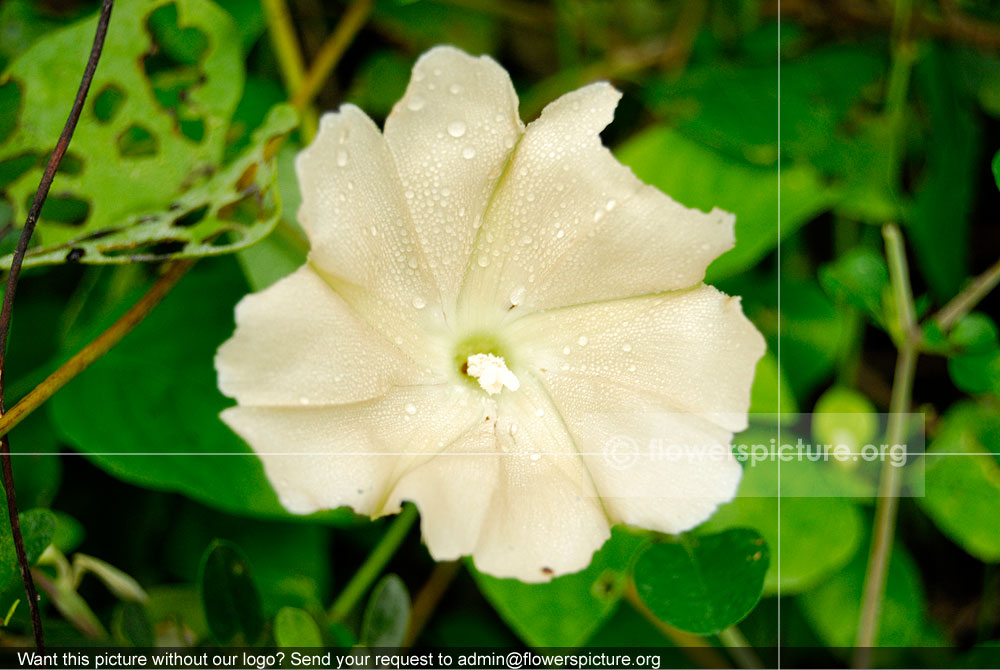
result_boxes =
[0,259,194,436]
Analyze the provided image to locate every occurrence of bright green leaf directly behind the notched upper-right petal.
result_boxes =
[616,126,834,282]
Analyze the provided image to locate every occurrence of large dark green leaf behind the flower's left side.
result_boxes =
[50,259,340,519]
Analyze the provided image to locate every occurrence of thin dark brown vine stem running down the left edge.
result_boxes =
[0,0,114,652]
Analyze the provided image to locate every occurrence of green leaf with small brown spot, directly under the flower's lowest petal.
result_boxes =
[470,528,646,647]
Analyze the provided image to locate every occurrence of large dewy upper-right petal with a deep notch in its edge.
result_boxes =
[465,83,733,320]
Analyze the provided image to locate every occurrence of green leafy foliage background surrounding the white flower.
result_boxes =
[0,0,1000,666]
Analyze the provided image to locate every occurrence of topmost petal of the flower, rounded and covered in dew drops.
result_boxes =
[385,47,523,312]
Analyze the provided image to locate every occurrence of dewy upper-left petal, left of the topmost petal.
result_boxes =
[295,105,445,362]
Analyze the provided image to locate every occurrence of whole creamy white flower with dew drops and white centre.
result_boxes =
[216,47,764,582]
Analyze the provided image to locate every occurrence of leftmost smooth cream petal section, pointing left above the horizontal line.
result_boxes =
[215,265,424,406]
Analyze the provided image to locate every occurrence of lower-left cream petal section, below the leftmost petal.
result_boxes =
[222,385,484,516]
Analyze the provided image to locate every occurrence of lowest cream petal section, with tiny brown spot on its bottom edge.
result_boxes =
[392,380,610,582]
